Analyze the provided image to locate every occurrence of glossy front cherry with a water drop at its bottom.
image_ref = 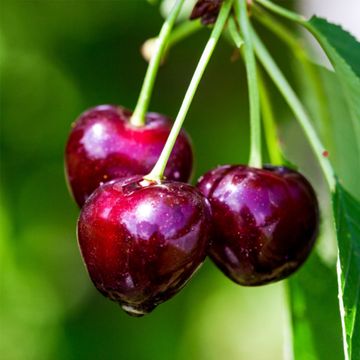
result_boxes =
[77,176,211,316]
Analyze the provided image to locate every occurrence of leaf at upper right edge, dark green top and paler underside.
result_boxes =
[306,17,360,177]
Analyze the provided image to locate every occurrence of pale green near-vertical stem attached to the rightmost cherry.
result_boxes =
[235,0,262,168]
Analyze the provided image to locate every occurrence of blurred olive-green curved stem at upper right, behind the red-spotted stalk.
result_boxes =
[252,5,331,145]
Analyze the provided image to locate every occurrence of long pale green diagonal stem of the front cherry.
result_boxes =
[145,0,233,181]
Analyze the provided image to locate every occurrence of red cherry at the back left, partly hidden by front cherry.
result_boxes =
[65,105,193,207]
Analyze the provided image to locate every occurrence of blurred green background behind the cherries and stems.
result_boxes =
[0,0,358,360]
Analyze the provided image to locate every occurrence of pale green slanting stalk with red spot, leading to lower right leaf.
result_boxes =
[252,31,335,191]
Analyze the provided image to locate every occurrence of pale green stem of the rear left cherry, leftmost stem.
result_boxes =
[130,0,185,126]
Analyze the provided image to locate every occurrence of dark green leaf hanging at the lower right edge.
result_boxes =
[333,183,360,360]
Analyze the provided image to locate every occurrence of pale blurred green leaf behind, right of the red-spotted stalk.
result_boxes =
[294,62,360,199]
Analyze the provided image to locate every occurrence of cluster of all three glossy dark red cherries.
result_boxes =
[65,105,319,316]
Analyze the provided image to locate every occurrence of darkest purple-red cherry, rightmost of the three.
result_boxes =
[198,165,319,286]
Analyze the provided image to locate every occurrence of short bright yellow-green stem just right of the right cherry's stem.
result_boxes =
[258,74,283,165]
